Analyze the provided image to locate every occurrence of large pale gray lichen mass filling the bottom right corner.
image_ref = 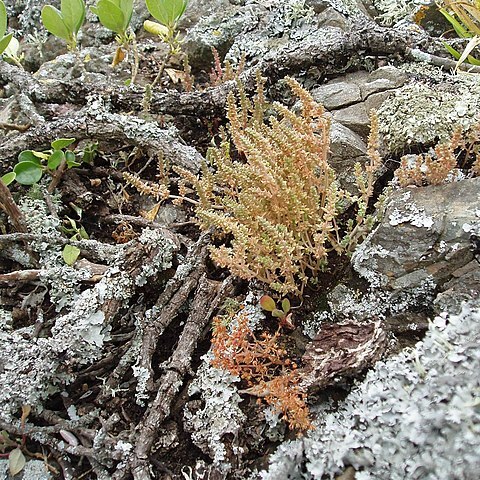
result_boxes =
[260,302,480,480]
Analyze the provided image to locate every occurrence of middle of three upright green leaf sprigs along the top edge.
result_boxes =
[90,0,134,66]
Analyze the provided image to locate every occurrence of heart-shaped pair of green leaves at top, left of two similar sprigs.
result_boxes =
[42,0,85,50]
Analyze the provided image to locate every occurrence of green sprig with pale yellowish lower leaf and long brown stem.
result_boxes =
[143,0,188,87]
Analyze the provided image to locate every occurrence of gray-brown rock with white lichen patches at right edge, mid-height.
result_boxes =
[352,178,480,291]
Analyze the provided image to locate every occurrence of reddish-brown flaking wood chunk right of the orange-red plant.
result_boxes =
[299,322,387,390]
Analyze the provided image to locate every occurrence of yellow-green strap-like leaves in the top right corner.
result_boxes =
[439,0,480,66]
